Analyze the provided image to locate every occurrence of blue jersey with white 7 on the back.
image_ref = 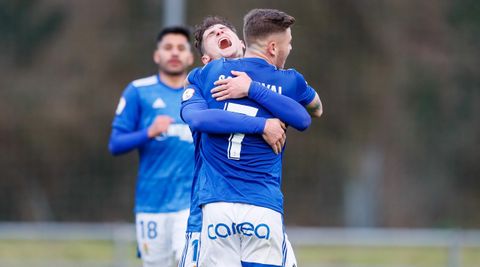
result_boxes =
[183,58,315,216]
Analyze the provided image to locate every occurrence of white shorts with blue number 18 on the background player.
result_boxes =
[135,209,189,267]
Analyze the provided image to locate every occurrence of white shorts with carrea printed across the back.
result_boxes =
[198,202,295,267]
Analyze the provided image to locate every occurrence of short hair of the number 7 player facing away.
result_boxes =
[243,9,295,46]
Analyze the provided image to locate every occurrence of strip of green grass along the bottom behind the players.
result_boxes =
[0,240,480,267]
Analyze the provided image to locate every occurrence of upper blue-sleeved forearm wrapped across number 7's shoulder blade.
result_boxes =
[248,82,312,131]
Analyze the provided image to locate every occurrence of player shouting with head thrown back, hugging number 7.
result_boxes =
[179,16,308,267]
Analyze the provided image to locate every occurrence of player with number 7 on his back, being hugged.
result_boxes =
[182,10,321,266]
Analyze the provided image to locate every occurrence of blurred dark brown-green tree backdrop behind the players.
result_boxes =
[0,0,480,228]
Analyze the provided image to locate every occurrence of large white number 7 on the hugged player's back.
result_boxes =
[224,103,258,160]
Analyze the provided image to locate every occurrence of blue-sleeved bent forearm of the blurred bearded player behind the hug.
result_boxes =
[108,129,150,155]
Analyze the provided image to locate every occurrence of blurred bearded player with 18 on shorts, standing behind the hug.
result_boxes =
[109,27,194,267]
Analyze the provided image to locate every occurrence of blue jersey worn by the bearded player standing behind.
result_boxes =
[112,75,194,212]
